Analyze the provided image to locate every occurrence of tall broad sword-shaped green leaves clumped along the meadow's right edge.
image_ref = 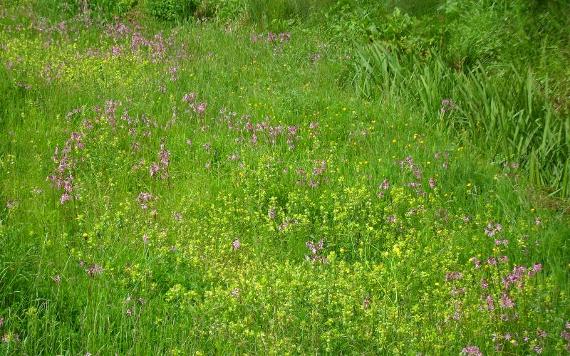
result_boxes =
[352,43,570,196]
